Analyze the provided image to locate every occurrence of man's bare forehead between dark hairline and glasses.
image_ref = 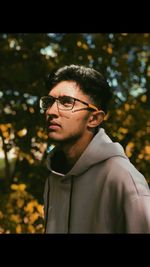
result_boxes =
[49,81,88,98]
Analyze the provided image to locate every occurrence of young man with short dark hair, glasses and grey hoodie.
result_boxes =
[40,65,150,233]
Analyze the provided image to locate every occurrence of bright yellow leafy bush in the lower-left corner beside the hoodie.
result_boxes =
[0,184,44,233]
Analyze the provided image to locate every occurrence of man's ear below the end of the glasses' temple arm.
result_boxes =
[87,110,105,128]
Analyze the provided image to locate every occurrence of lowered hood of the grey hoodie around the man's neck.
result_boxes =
[47,128,129,176]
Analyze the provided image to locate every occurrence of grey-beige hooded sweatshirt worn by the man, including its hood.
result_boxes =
[44,128,150,233]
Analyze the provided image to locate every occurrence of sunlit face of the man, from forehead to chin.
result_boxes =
[46,81,94,146]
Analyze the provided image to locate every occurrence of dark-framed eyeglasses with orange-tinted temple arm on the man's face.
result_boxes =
[40,95,98,111]
